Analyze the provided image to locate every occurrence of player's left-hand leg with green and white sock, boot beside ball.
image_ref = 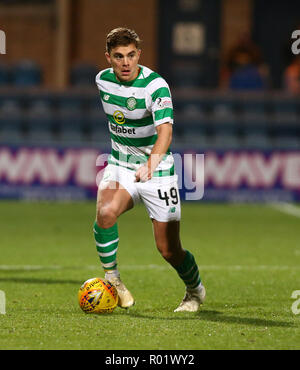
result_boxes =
[94,176,134,308]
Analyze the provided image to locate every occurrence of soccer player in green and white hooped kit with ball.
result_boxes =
[94,27,205,312]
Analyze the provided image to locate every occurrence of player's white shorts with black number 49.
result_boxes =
[99,164,181,222]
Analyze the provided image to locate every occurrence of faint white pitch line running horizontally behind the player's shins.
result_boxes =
[0,264,300,271]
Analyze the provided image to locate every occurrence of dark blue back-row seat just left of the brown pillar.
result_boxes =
[12,60,42,87]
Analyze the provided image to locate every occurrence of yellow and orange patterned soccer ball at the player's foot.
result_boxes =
[78,278,118,313]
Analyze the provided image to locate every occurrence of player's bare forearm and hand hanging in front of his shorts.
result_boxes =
[135,123,173,182]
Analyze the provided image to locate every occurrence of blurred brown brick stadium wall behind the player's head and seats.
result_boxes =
[0,0,253,89]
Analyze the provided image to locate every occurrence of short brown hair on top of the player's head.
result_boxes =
[106,27,141,53]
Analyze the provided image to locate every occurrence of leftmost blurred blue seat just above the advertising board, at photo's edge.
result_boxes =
[0,99,24,143]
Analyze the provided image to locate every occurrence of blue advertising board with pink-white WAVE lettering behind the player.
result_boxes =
[0,146,300,202]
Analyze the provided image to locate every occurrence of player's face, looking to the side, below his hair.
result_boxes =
[105,44,141,82]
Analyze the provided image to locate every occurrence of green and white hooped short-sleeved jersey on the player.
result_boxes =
[96,66,174,176]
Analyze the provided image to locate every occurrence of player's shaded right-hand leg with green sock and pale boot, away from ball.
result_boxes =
[152,219,206,312]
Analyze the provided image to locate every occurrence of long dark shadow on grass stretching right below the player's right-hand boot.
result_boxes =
[130,310,295,328]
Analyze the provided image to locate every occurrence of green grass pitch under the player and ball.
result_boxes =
[0,202,300,350]
